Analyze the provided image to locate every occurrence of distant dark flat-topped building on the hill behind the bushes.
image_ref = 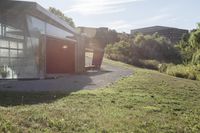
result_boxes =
[131,26,188,43]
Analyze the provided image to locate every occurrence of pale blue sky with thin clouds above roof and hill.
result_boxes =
[18,0,200,33]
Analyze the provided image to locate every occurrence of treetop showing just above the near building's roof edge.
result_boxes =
[49,7,75,27]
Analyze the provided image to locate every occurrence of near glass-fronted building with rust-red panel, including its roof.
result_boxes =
[0,0,85,79]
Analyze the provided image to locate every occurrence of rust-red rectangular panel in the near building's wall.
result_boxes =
[46,37,75,74]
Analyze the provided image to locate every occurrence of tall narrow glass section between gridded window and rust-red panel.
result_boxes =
[25,16,45,77]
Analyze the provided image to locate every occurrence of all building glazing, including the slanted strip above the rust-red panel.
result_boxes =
[0,15,73,79]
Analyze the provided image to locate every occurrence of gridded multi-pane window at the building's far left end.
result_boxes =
[0,21,25,78]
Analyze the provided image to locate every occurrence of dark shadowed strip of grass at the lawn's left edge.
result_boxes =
[0,91,70,107]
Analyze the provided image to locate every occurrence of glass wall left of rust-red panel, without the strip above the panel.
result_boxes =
[0,17,45,79]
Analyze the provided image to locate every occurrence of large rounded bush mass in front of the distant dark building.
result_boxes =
[105,34,181,65]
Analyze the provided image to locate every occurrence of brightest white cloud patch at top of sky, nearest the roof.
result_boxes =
[65,0,143,15]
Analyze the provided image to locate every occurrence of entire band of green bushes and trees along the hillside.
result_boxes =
[106,23,200,80]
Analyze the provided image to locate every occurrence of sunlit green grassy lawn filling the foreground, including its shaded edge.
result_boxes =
[0,60,200,133]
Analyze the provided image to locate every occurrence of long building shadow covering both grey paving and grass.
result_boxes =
[0,70,111,107]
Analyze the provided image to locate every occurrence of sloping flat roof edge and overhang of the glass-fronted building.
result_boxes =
[0,0,78,34]
